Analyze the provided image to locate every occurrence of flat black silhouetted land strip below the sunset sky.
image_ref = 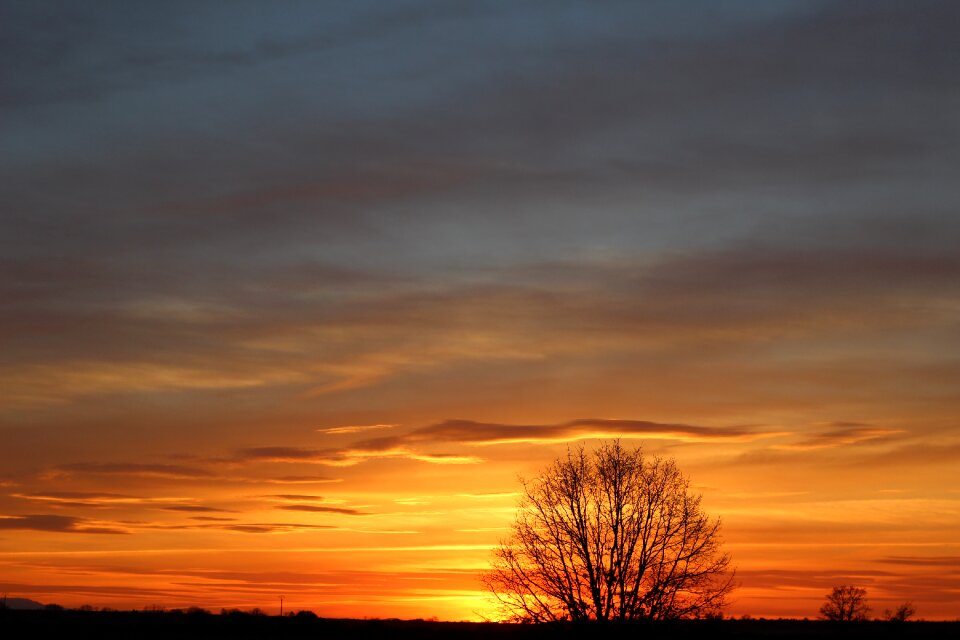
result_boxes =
[0,610,960,640]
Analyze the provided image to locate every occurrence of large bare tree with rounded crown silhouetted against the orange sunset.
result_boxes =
[484,441,733,622]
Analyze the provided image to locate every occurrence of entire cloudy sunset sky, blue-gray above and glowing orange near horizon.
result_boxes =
[0,0,960,620]
